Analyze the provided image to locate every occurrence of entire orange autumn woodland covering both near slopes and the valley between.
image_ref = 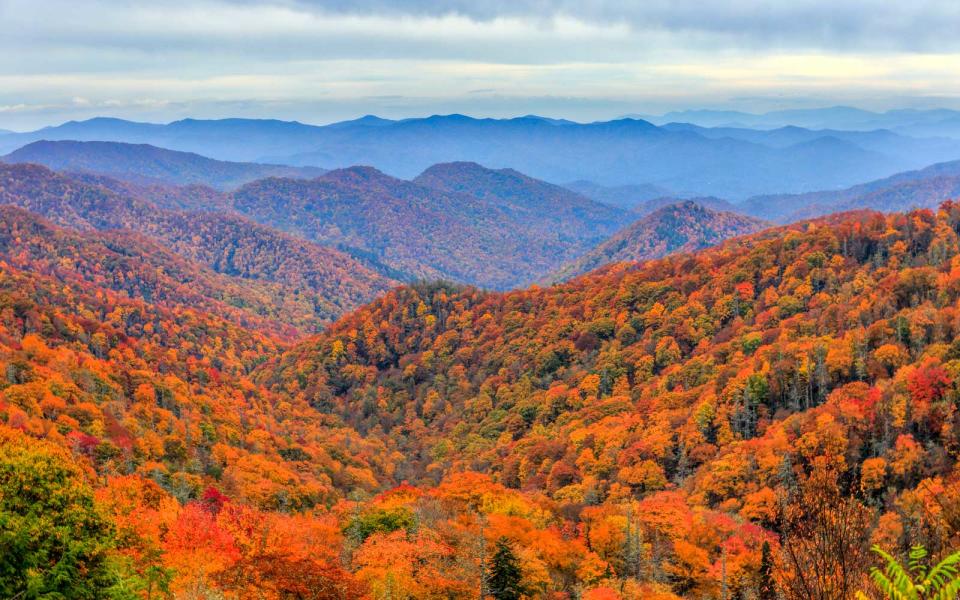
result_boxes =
[0,154,960,600]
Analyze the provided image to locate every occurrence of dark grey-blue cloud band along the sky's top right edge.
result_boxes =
[253,0,960,51]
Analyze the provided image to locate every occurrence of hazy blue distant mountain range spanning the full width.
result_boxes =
[0,115,960,198]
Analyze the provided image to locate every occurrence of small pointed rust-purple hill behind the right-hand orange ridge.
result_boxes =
[551,200,768,280]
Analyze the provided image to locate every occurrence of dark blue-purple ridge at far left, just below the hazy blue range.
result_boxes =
[0,140,325,189]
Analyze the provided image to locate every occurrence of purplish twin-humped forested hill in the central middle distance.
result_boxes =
[233,167,632,288]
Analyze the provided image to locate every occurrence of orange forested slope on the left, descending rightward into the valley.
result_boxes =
[0,206,398,506]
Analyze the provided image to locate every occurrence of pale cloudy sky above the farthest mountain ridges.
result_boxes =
[0,0,960,130]
